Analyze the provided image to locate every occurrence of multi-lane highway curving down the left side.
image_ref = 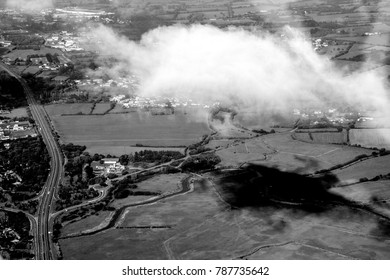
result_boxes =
[0,63,62,260]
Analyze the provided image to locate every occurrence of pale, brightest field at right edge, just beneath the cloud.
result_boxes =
[349,128,390,148]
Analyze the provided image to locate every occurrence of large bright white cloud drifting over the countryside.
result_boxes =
[88,25,390,127]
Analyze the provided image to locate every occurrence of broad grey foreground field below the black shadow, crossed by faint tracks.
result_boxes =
[60,177,390,259]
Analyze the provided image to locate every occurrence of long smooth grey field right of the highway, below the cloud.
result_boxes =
[48,107,213,148]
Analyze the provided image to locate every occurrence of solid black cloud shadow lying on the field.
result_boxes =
[218,164,347,212]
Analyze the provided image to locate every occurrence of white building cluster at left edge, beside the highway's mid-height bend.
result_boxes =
[0,120,37,141]
